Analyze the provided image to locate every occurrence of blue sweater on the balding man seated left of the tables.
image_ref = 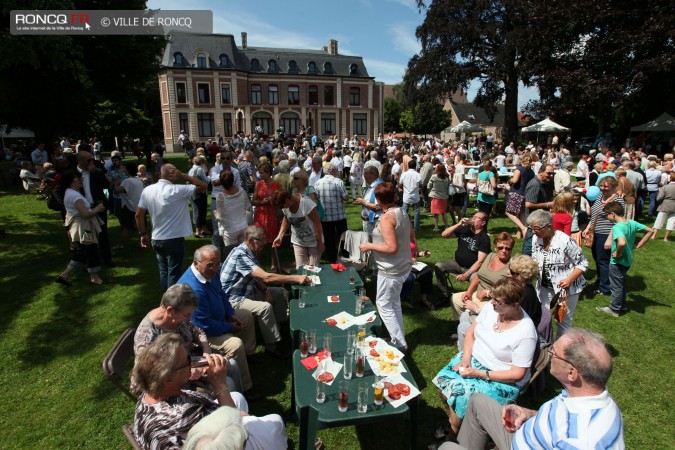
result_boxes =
[178,265,234,337]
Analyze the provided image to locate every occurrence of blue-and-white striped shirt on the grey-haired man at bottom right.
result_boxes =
[511,390,625,450]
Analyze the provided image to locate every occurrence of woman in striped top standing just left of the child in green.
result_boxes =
[581,177,626,295]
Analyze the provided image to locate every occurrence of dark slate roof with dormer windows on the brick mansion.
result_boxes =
[161,33,370,78]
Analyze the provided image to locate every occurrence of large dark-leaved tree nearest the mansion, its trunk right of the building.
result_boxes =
[404,0,540,140]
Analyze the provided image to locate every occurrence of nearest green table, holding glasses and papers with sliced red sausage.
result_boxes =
[291,332,419,450]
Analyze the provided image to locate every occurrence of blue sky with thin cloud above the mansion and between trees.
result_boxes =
[148,0,537,106]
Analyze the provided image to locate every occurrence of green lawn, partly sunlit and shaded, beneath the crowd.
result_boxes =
[0,156,675,449]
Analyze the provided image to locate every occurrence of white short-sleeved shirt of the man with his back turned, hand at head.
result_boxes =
[138,179,197,240]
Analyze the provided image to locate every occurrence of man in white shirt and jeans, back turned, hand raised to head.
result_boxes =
[136,164,208,292]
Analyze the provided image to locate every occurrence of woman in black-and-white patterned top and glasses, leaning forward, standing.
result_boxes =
[527,209,588,338]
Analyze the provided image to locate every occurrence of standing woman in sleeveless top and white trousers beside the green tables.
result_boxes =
[359,182,415,352]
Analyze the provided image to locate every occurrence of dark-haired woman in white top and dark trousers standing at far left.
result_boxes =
[54,171,105,286]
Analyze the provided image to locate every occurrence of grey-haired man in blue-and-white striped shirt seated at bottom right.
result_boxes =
[440,328,625,450]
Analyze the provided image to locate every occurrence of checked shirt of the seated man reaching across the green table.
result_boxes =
[220,242,260,304]
